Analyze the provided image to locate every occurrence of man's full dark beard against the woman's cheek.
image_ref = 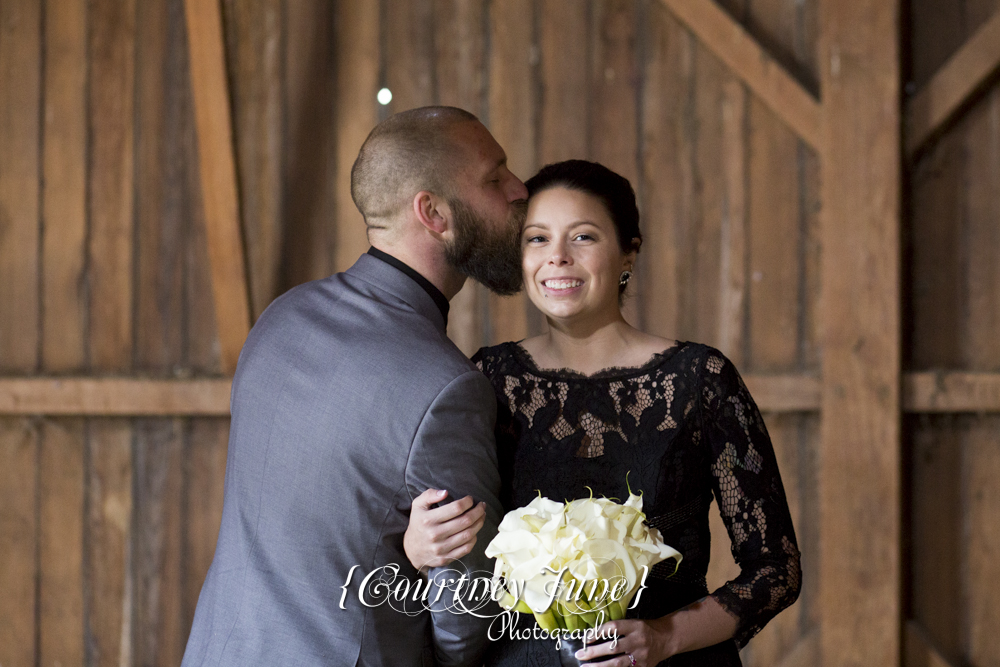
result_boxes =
[444,199,528,296]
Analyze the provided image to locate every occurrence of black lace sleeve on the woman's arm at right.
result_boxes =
[701,350,802,647]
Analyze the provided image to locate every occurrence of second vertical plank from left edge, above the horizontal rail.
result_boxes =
[42,0,87,371]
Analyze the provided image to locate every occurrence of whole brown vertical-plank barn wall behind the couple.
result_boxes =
[0,0,1000,667]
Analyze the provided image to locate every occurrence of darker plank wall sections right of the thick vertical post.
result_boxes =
[903,0,1000,665]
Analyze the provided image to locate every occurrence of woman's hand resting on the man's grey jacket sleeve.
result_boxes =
[403,489,486,572]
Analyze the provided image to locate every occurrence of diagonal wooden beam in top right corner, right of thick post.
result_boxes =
[905,10,1000,159]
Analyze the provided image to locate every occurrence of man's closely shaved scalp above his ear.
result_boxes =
[351,106,479,227]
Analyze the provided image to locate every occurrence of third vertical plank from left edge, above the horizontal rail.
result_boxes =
[87,0,136,372]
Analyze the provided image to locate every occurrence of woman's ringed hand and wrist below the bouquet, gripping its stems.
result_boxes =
[576,616,674,667]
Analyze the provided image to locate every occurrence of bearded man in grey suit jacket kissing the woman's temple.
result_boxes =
[183,107,527,667]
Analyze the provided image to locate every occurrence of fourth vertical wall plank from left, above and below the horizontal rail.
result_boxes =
[130,0,188,665]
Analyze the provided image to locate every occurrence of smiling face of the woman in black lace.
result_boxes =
[521,187,635,320]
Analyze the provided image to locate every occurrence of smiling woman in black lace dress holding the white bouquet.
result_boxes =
[405,160,800,667]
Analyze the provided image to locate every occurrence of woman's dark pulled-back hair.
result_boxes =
[525,160,642,252]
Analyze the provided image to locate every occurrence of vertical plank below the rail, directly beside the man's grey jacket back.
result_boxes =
[182,419,229,637]
